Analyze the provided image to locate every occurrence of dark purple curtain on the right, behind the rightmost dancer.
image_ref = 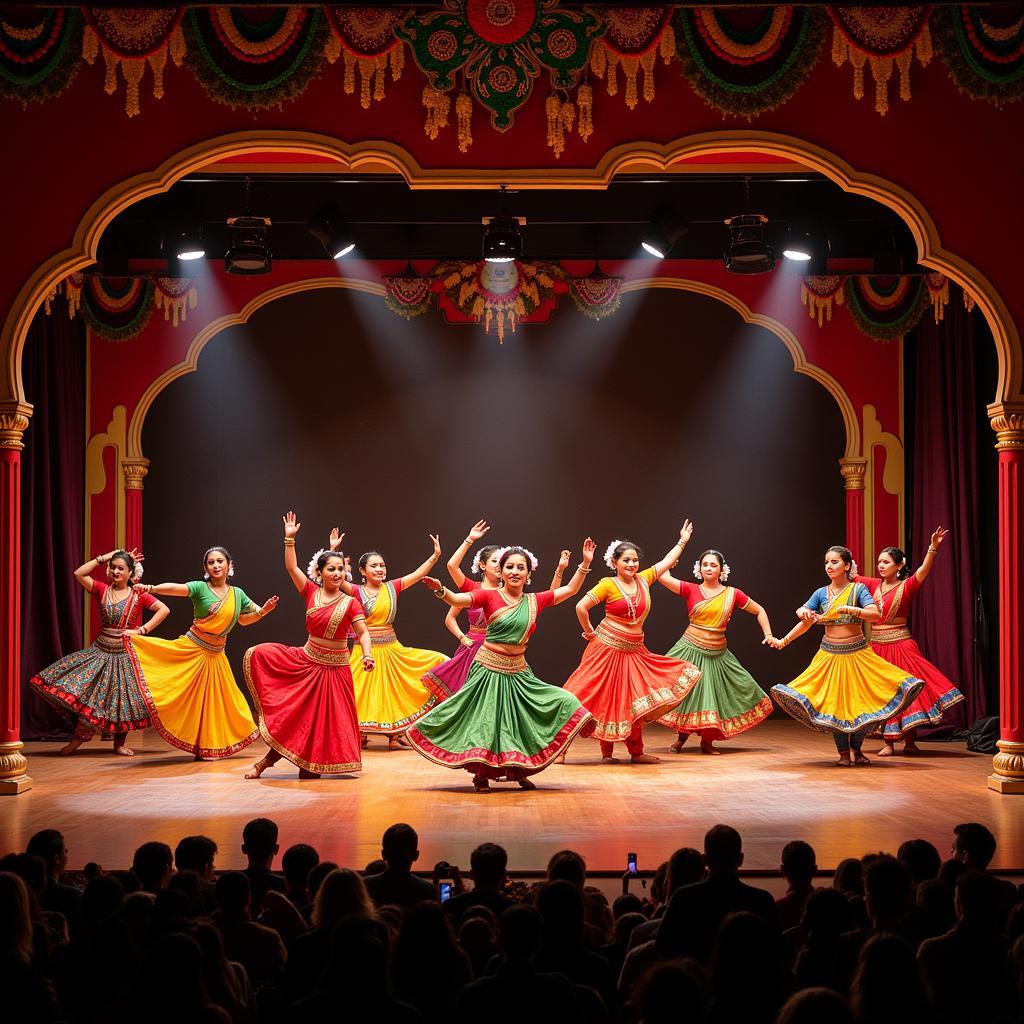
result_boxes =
[907,288,988,731]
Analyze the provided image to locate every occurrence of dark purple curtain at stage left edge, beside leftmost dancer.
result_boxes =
[22,300,85,739]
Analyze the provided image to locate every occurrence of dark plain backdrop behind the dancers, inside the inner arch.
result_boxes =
[143,289,847,688]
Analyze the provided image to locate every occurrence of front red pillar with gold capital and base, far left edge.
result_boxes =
[0,401,32,794]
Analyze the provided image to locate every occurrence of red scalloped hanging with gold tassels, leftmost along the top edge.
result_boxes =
[82,7,185,118]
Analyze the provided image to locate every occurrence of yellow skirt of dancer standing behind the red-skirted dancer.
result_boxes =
[349,640,449,733]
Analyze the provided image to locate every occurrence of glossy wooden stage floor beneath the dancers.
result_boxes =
[0,721,1024,870]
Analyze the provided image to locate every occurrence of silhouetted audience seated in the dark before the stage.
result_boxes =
[9,818,1024,1024]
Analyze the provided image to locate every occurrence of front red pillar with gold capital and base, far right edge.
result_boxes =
[988,402,1024,793]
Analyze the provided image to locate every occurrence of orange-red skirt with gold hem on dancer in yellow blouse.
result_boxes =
[565,621,700,740]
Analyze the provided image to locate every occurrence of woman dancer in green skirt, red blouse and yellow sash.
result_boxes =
[658,549,772,754]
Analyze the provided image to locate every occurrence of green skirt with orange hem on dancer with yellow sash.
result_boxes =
[658,637,772,739]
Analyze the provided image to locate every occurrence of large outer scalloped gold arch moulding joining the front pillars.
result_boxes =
[0,129,1024,402]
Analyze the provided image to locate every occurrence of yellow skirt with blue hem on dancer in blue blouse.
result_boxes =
[771,640,925,732]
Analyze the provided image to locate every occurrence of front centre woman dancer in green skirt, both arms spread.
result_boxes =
[407,537,594,792]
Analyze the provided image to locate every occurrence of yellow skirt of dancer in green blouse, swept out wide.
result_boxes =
[126,636,259,759]
